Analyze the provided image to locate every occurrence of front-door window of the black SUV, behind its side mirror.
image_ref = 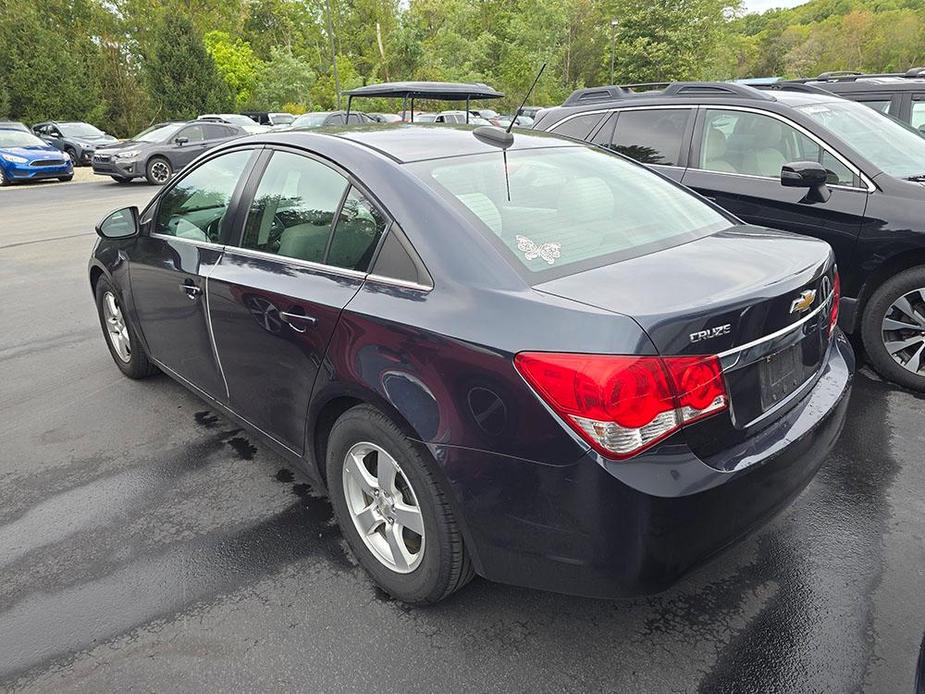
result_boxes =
[700,109,855,186]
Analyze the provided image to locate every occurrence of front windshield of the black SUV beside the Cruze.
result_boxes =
[796,101,925,178]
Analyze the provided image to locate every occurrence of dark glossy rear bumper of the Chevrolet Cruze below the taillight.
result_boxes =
[429,332,854,598]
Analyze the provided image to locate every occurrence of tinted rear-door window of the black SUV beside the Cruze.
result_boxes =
[613,109,692,166]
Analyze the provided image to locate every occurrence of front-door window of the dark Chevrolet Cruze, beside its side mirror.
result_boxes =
[155,150,251,243]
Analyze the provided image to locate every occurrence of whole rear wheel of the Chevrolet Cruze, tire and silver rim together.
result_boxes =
[326,405,474,604]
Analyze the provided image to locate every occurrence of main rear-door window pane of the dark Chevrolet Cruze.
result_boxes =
[241,152,347,263]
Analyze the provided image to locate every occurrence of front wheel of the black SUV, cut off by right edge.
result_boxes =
[861,266,925,391]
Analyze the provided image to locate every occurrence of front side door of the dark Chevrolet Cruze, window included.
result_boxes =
[129,149,255,401]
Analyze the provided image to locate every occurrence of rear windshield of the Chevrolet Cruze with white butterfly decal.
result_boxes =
[408,147,730,281]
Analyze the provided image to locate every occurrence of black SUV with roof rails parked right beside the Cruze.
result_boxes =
[534,82,925,390]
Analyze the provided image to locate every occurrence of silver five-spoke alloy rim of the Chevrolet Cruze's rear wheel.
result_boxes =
[343,442,424,574]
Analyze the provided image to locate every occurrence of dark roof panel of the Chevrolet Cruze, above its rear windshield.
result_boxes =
[279,123,582,163]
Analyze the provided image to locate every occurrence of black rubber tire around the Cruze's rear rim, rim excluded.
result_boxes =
[326,405,452,603]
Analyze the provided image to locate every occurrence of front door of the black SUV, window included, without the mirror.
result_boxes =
[682,106,869,272]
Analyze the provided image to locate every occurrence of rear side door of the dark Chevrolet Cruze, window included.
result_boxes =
[208,149,387,454]
